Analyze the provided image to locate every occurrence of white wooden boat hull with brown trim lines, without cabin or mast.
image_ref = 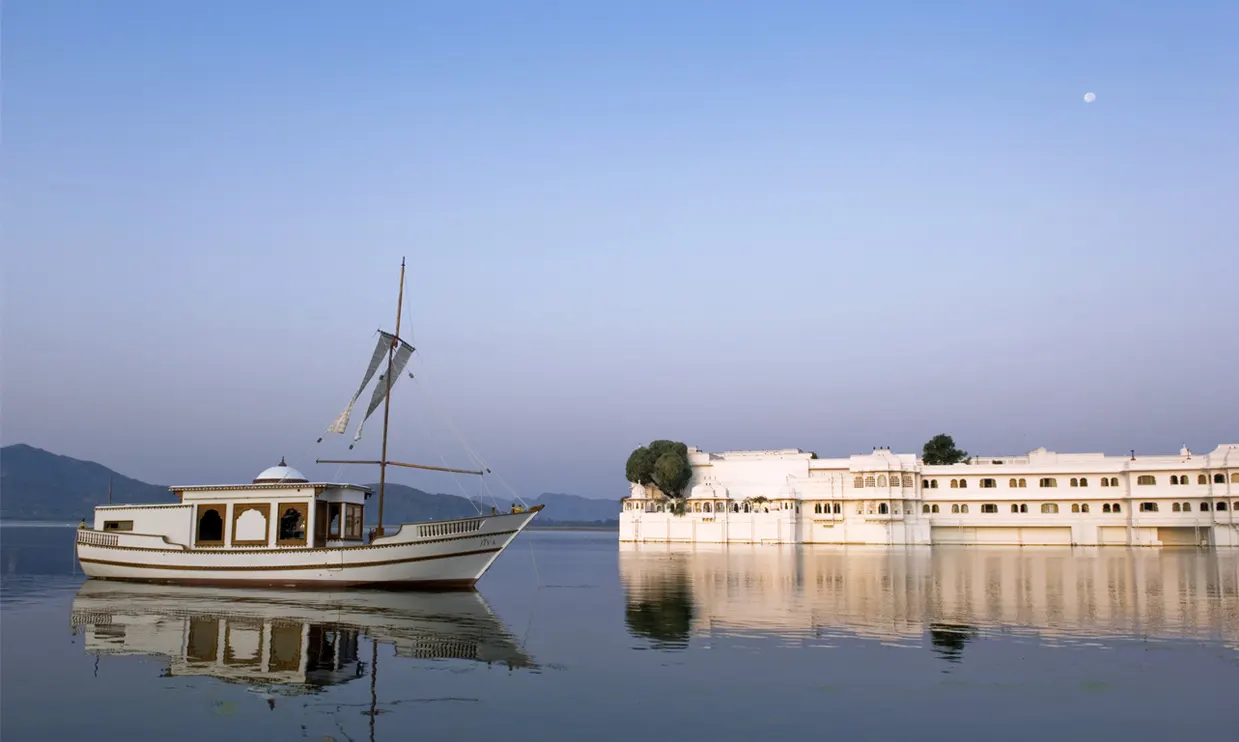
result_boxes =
[77,507,541,590]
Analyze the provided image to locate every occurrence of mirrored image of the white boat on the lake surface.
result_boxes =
[72,580,535,705]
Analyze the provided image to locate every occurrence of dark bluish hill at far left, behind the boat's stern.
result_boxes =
[0,443,176,520]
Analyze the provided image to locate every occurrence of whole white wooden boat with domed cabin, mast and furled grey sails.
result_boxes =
[76,260,543,590]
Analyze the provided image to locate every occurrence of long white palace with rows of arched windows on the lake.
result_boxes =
[620,443,1239,546]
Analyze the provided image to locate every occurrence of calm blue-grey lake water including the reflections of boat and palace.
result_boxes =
[0,528,1239,742]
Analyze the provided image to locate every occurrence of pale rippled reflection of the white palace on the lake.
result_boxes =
[620,543,1239,661]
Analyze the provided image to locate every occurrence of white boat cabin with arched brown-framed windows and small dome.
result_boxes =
[94,460,372,549]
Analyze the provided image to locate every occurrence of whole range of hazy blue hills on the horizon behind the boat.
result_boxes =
[0,443,620,526]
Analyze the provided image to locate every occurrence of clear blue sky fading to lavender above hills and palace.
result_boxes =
[0,0,1239,498]
